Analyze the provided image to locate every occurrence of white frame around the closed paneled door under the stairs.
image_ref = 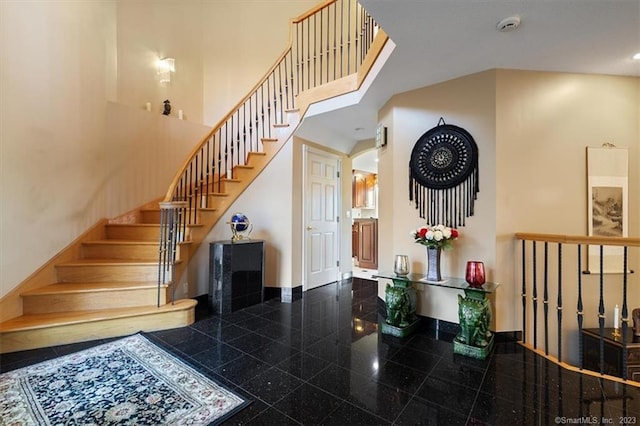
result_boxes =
[300,144,342,292]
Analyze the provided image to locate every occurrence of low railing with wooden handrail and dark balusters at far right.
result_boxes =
[516,233,640,380]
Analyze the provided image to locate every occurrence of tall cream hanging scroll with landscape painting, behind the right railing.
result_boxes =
[587,144,629,274]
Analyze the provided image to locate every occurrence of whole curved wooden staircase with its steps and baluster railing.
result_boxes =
[0,0,387,353]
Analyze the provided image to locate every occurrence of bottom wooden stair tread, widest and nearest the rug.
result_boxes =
[0,299,198,333]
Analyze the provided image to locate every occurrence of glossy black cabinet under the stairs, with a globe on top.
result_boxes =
[209,240,265,314]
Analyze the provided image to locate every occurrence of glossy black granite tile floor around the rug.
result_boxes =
[0,278,640,426]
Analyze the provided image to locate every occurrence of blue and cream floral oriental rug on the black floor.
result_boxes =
[0,334,248,425]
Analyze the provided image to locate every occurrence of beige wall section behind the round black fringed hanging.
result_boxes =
[378,71,496,322]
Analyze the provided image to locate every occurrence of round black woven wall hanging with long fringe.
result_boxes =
[409,118,479,228]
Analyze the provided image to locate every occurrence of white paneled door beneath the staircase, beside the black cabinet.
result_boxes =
[303,147,340,291]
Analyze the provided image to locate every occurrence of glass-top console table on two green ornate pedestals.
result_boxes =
[373,272,499,359]
